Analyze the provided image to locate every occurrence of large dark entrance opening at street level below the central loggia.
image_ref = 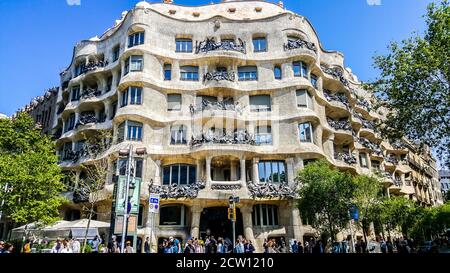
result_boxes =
[200,207,244,240]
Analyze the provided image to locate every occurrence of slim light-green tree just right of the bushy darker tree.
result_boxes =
[353,175,383,243]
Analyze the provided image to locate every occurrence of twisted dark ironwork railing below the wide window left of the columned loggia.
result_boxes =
[148,181,206,199]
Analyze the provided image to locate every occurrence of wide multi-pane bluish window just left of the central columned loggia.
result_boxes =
[163,164,197,185]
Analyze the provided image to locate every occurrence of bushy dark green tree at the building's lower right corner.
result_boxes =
[297,160,355,240]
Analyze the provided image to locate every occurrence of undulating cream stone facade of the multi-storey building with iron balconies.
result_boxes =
[53,1,439,251]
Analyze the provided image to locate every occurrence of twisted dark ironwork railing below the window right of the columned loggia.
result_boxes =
[247,181,298,199]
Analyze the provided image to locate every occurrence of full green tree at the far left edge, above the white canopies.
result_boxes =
[0,113,65,225]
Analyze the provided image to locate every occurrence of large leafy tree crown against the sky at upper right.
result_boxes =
[369,0,450,165]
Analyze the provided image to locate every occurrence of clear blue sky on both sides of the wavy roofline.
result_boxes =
[0,0,431,115]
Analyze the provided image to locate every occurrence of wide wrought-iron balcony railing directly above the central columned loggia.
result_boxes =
[191,131,256,147]
